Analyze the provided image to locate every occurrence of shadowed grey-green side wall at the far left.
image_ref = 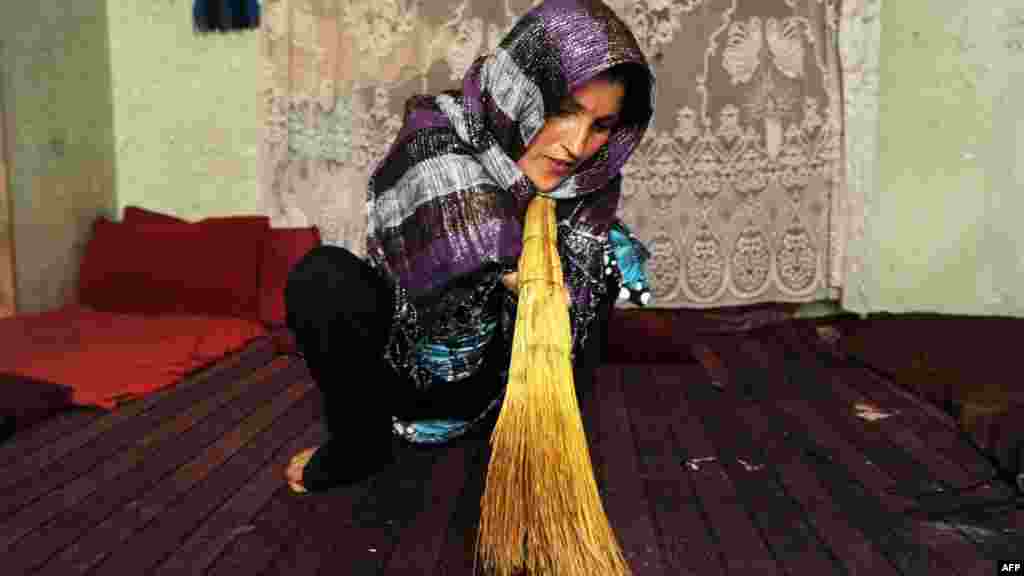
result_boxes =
[0,0,115,313]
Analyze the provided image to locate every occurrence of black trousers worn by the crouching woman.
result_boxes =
[285,246,617,449]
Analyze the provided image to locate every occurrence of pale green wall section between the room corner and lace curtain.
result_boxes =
[108,0,263,218]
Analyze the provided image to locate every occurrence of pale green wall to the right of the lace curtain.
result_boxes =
[867,0,1024,316]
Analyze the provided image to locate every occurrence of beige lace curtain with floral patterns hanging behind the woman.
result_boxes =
[260,0,877,307]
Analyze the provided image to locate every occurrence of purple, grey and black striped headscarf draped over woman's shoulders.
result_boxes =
[367,0,654,305]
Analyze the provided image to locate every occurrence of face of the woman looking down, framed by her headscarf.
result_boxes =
[517,78,626,192]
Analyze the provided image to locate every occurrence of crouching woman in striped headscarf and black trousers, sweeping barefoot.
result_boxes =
[286,0,653,491]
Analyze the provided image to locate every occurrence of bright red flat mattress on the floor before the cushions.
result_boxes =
[0,305,267,408]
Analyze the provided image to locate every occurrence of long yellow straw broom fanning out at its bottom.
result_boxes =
[476,196,630,576]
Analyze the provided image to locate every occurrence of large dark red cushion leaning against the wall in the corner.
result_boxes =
[79,217,269,320]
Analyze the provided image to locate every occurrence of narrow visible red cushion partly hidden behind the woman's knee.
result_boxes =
[259,227,321,326]
